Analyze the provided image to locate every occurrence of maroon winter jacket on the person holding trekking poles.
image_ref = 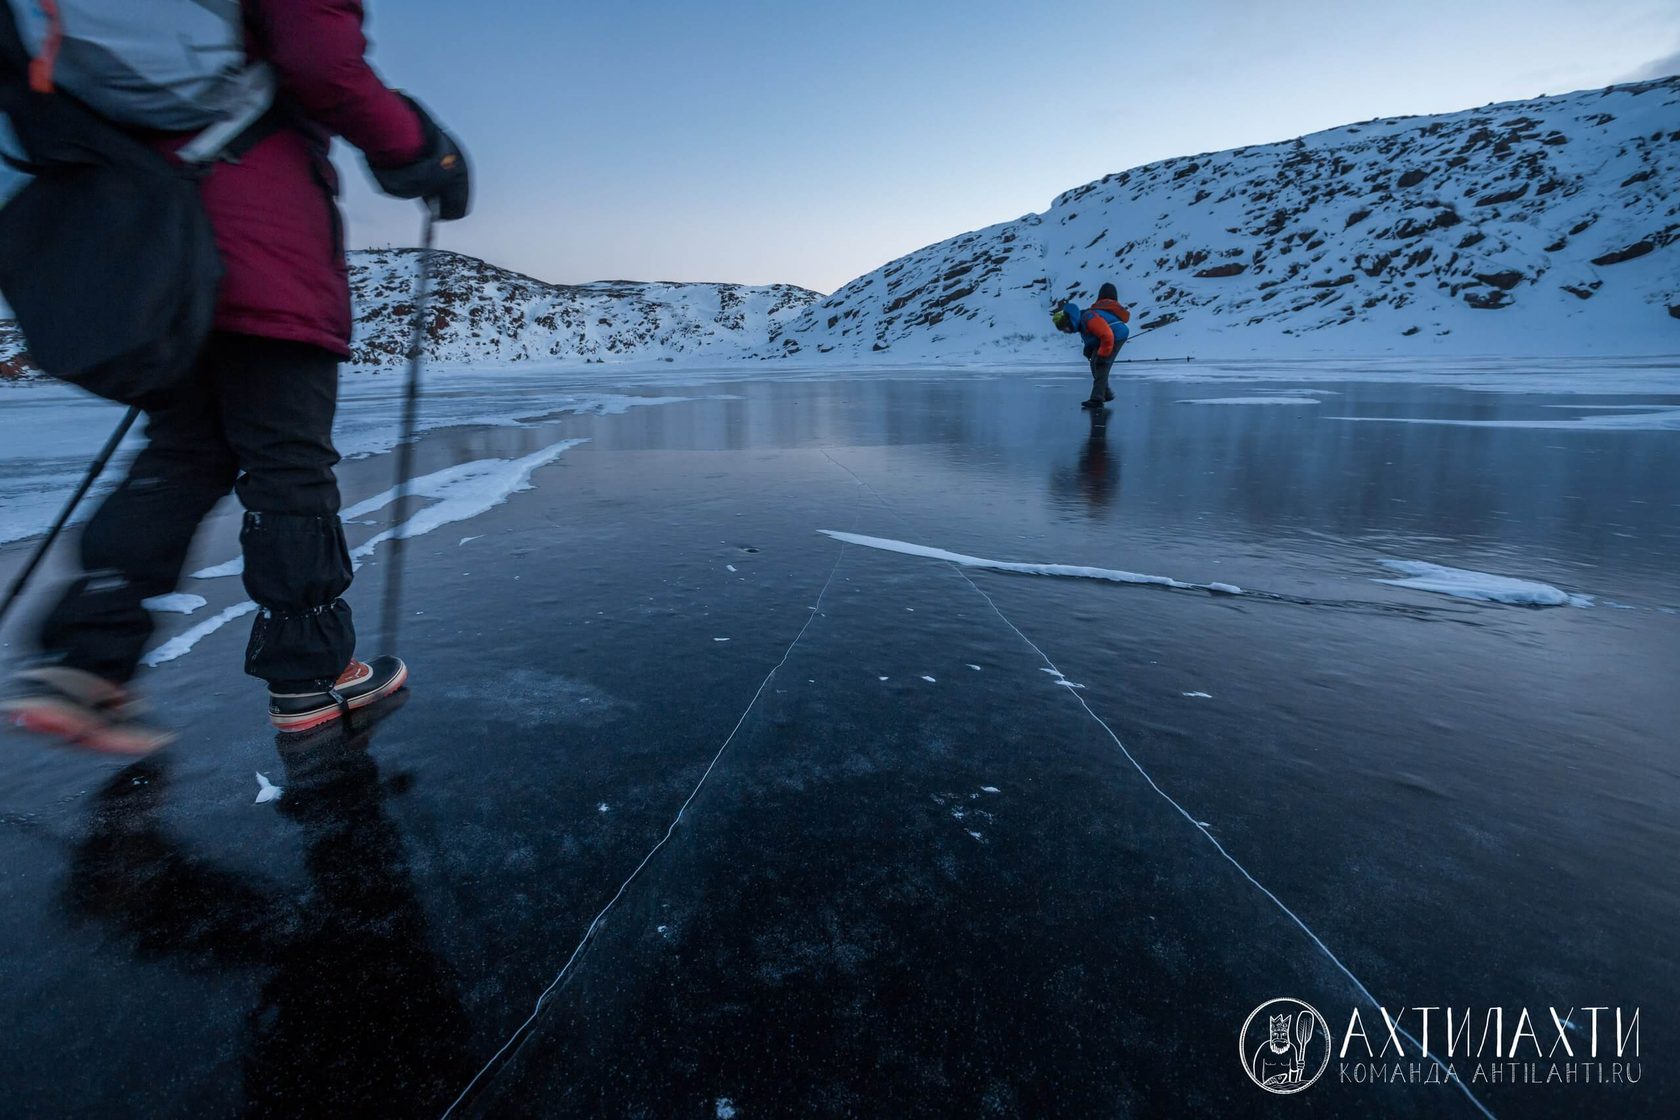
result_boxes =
[178,0,425,356]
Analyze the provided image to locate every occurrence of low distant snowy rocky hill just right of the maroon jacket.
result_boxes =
[349,249,820,366]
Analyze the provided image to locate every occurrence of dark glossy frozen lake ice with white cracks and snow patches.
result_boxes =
[0,363,1680,1117]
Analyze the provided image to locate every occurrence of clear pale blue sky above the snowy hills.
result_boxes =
[341,0,1680,292]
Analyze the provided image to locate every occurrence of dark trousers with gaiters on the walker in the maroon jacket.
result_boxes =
[40,334,356,690]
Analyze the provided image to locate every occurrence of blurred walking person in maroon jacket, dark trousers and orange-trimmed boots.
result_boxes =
[3,0,469,754]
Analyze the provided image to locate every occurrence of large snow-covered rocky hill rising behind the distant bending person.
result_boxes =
[768,79,1680,359]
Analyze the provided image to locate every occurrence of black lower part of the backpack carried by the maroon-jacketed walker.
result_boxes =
[0,3,282,408]
